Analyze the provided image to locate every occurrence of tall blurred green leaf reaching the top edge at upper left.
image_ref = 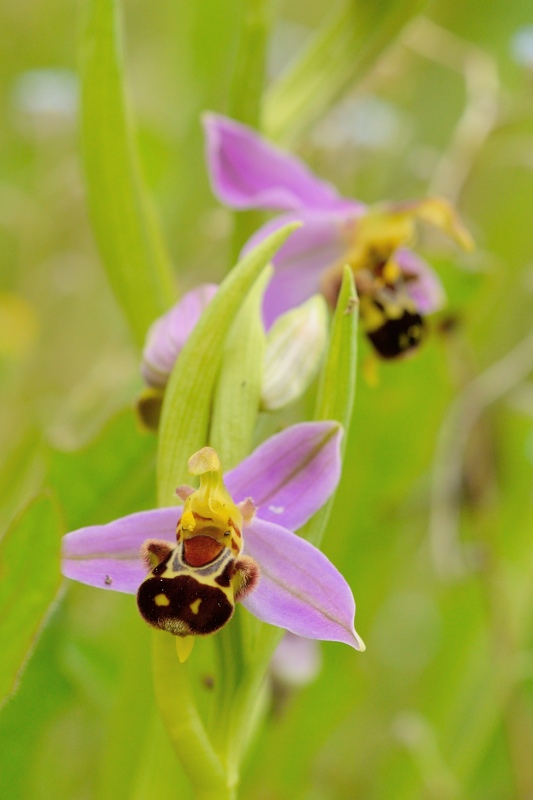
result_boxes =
[81,0,175,345]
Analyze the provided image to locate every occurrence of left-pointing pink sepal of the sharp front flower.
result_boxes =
[62,507,181,594]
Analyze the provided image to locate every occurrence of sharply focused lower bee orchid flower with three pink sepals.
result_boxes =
[63,422,364,650]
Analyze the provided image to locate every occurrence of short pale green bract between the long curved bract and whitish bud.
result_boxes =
[209,268,272,470]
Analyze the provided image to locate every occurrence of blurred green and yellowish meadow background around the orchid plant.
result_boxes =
[0,0,533,800]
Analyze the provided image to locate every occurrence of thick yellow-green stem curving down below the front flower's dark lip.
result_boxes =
[153,631,235,800]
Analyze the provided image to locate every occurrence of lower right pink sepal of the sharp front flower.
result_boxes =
[243,519,364,650]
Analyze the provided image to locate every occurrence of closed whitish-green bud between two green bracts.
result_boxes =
[261,295,328,411]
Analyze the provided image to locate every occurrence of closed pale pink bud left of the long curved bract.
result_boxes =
[141,283,218,388]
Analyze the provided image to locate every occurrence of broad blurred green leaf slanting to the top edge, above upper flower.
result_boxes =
[263,0,426,142]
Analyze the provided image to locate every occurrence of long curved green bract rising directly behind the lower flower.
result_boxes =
[158,223,299,505]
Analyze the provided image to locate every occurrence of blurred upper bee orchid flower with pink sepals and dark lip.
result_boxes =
[204,114,472,358]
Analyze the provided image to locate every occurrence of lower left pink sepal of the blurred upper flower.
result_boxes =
[244,211,360,329]
